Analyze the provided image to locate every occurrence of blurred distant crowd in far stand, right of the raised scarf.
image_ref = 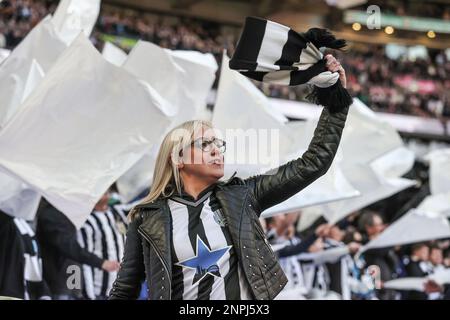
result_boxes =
[339,46,450,118]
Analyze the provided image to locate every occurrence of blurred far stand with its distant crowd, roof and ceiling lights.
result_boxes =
[0,0,450,122]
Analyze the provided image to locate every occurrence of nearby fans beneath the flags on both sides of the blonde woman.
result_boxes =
[0,188,450,300]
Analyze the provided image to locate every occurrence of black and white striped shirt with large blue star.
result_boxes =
[168,188,251,300]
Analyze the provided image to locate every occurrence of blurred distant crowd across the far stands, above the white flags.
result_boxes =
[0,0,450,118]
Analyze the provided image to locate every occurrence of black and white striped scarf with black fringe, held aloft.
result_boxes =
[230,17,352,112]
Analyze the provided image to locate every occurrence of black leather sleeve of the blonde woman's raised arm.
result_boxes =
[245,107,349,212]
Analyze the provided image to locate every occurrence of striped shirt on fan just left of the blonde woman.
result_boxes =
[77,206,126,300]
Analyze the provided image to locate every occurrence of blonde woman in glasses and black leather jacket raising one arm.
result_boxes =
[110,55,348,300]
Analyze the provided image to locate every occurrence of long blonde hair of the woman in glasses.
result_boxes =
[130,120,213,219]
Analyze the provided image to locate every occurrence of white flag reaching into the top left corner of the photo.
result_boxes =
[0,0,100,129]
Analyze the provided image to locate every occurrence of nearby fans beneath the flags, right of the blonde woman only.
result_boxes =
[267,210,450,300]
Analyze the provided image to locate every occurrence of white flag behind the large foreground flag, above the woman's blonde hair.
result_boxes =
[117,41,217,201]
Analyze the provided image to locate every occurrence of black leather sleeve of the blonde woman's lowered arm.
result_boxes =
[109,215,145,300]
